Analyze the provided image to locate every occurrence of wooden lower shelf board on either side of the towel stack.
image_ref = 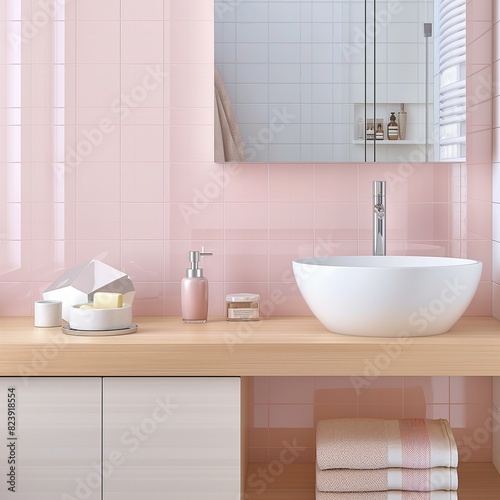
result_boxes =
[245,463,500,500]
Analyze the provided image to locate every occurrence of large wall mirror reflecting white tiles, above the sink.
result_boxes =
[215,0,466,163]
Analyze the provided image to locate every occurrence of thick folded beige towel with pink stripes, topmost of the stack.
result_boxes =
[316,418,458,470]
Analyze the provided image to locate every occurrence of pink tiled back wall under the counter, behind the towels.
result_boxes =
[248,377,492,463]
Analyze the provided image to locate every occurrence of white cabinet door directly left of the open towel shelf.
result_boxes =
[103,377,240,500]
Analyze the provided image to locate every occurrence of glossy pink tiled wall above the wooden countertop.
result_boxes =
[0,0,491,316]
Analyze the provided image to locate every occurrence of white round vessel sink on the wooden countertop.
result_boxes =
[293,256,482,337]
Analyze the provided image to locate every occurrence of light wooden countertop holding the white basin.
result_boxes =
[0,317,500,376]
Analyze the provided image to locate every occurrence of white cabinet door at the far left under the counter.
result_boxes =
[0,377,102,500]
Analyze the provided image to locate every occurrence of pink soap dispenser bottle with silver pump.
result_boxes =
[181,249,212,323]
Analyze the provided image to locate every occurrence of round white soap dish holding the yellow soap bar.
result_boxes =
[69,304,132,331]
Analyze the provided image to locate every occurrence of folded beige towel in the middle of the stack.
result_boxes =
[316,467,458,492]
